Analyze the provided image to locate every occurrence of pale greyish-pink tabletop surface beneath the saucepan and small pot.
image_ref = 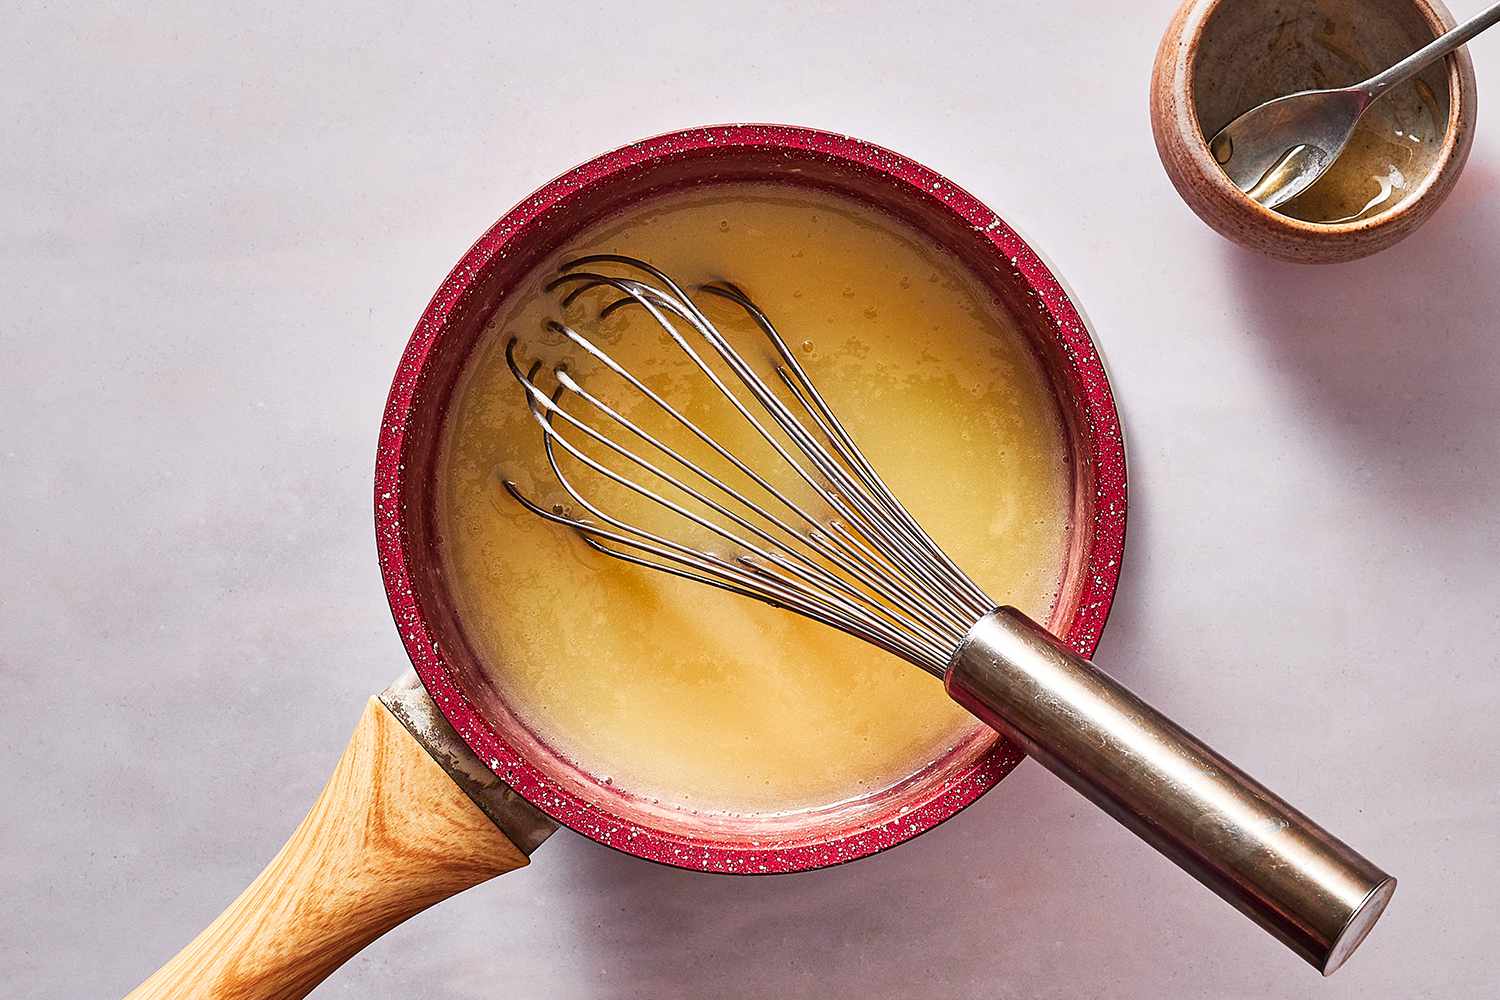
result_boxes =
[0,0,1500,1000]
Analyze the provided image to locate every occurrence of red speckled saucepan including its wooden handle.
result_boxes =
[126,126,1125,997]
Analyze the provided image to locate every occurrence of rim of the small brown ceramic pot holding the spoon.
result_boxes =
[1173,0,1475,240]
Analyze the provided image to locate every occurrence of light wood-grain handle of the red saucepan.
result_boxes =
[126,699,527,1000]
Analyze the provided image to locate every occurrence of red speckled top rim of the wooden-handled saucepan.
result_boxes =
[374,124,1127,874]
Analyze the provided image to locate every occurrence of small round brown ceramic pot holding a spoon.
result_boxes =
[1151,0,1475,264]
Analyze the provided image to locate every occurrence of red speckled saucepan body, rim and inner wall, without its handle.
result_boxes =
[375,126,1125,873]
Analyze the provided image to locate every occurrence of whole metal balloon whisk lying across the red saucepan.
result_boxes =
[504,253,1395,975]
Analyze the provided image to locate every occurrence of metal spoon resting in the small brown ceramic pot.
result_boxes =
[1209,3,1500,208]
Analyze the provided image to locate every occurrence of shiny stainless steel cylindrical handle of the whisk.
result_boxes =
[944,607,1397,976]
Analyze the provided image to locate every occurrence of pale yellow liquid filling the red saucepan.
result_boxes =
[437,184,1071,814]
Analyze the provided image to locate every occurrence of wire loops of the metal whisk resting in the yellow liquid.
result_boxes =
[504,253,996,676]
